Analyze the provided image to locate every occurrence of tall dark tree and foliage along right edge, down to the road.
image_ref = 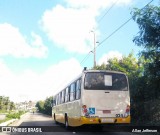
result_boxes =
[132,5,160,125]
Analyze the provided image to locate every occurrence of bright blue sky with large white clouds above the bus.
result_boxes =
[0,0,159,102]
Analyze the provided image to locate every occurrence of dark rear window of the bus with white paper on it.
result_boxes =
[84,72,128,91]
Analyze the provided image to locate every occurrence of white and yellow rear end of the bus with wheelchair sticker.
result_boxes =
[81,70,130,125]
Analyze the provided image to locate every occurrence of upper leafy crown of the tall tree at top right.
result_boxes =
[132,5,160,51]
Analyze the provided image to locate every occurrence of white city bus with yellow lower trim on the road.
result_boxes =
[52,69,130,128]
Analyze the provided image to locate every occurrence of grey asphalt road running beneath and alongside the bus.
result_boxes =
[2,113,138,135]
